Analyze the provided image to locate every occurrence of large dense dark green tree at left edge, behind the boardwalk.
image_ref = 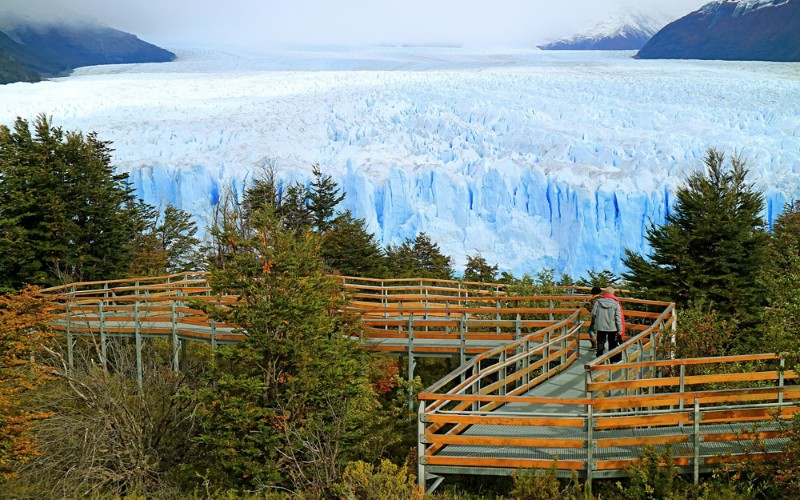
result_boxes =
[0,115,137,288]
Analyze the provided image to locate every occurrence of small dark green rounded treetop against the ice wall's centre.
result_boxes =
[386,233,454,280]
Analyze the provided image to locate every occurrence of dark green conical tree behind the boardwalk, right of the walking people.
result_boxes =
[623,149,767,320]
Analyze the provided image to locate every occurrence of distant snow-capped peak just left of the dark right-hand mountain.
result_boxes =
[539,10,670,50]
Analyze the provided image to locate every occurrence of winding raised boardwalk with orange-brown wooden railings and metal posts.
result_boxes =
[45,273,800,490]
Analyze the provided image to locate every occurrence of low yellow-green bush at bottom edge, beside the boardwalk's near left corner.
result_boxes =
[334,460,422,500]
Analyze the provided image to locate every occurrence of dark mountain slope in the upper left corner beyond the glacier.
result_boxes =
[0,21,175,83]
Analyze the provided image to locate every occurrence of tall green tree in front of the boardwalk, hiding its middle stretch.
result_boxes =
[191,206,381,496]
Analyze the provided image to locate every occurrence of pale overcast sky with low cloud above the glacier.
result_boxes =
[0,0,709,46]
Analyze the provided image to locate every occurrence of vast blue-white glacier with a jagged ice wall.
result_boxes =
[0,46,800,277]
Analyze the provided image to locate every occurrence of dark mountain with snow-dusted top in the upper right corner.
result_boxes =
[636,0,800,62]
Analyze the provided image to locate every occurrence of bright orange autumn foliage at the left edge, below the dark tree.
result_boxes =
[0,288,50,478]
